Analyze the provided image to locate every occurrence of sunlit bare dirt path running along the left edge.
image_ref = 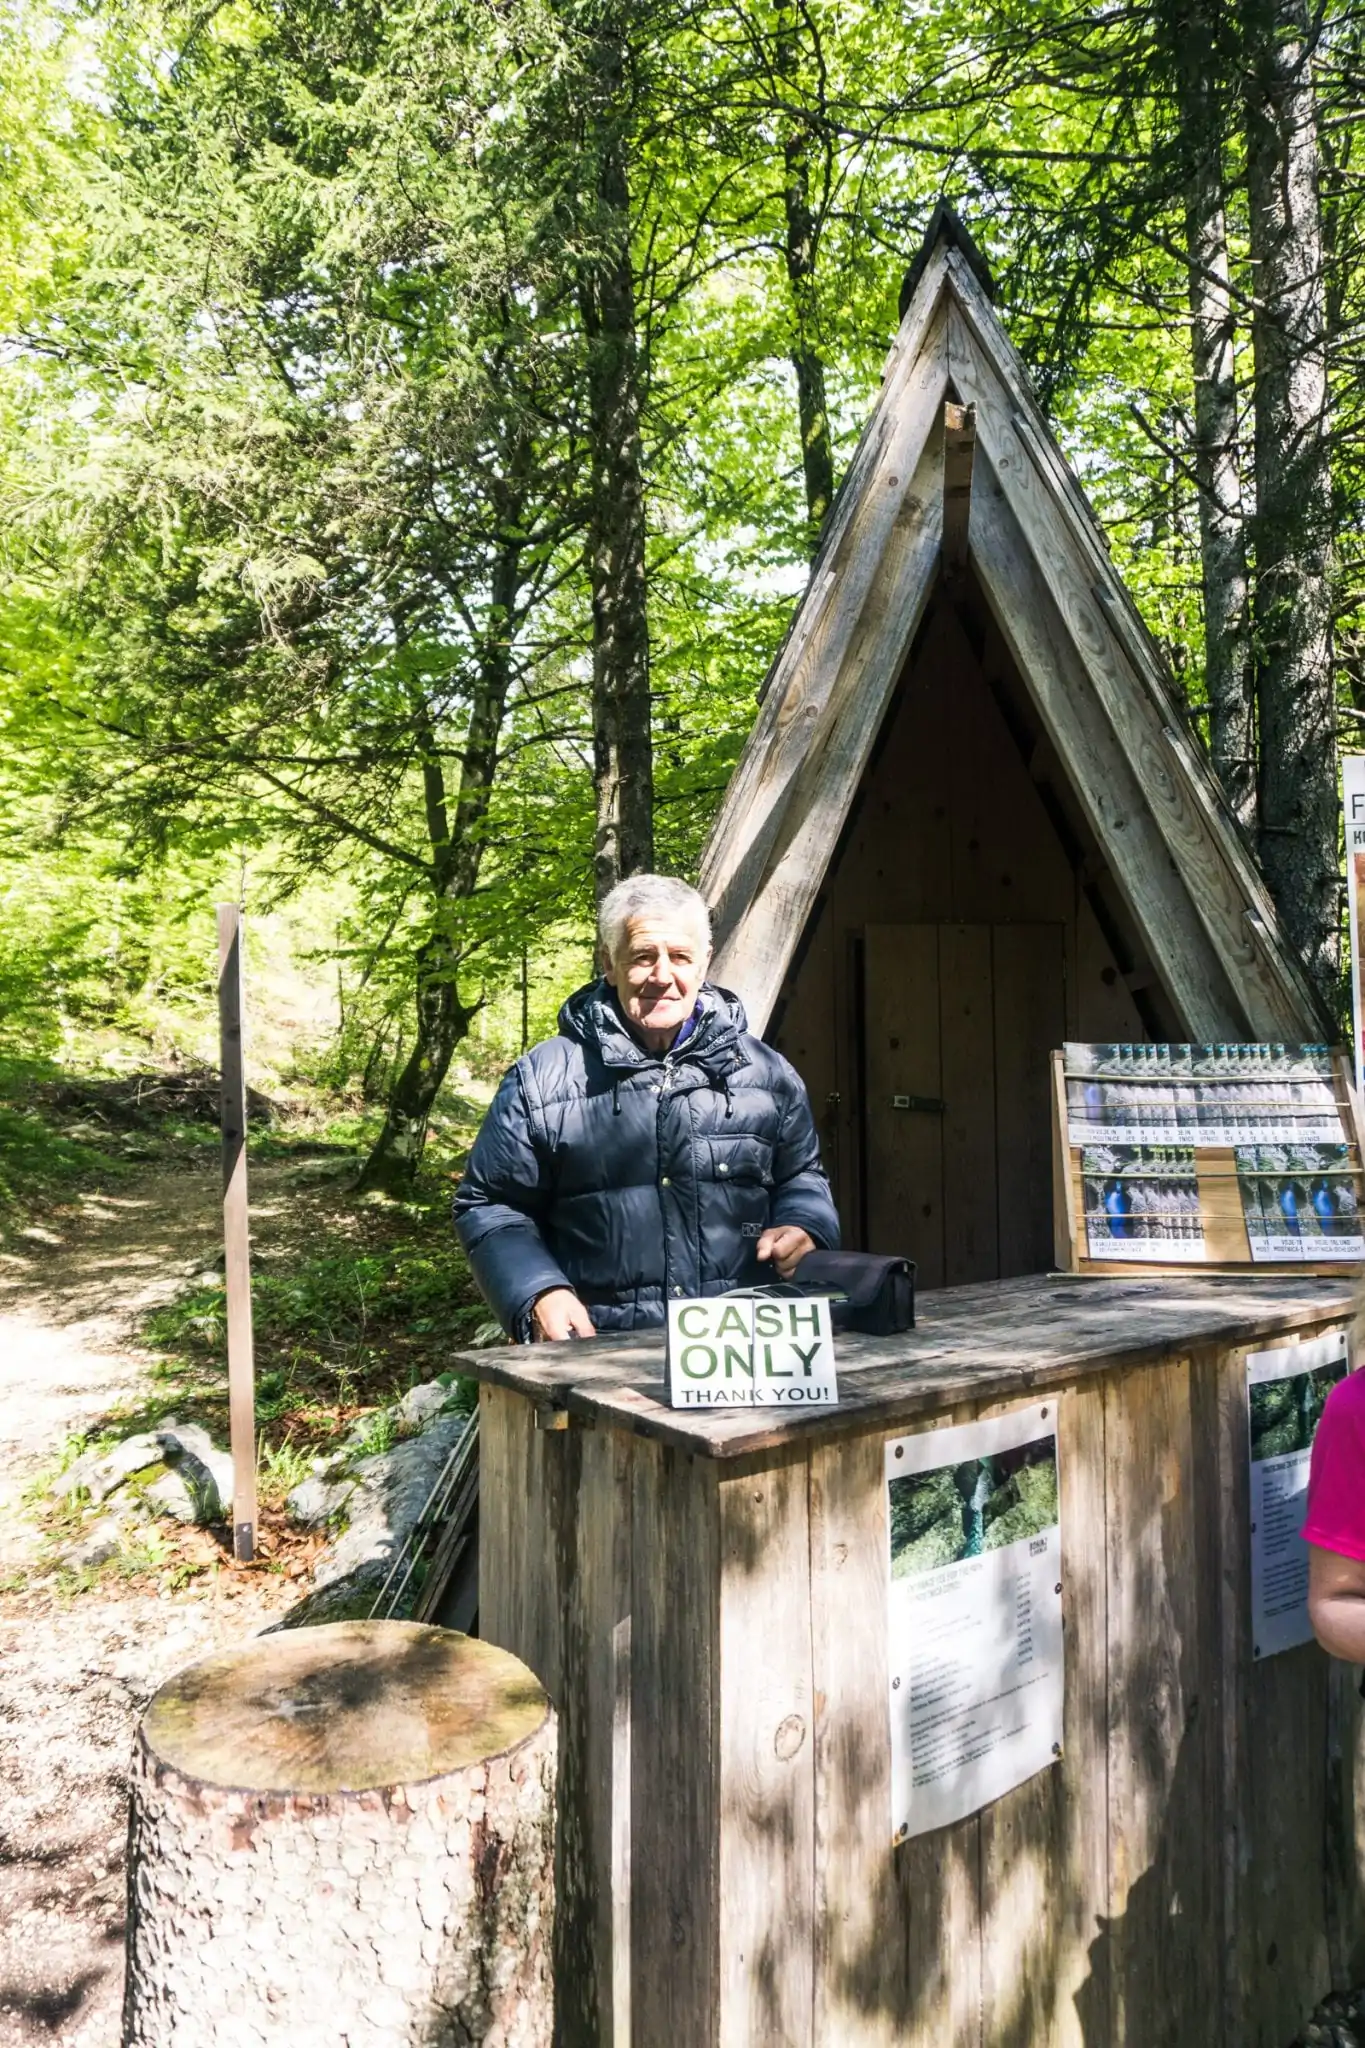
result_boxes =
[0,1157,293,2048]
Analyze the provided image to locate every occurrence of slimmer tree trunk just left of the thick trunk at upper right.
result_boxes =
[1162,0,1257,829]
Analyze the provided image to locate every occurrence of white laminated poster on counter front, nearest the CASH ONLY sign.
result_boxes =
[886,1401,1062,1841]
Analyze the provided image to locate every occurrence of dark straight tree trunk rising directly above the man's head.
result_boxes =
[579,18,655,901]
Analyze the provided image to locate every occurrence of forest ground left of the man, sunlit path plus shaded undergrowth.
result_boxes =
[0,1064,483,2048]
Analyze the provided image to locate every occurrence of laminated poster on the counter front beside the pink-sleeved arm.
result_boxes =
[1246,1329,1347,1657]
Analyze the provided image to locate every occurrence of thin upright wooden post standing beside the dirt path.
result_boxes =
[219,903,256,1565]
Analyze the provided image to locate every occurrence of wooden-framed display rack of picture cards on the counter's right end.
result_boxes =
[1052,1044,1365,1274]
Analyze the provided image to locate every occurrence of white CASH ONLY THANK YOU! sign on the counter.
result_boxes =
[669,1294,839,1413]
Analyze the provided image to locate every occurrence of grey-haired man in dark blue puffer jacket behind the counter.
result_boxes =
[454,874,839,1343]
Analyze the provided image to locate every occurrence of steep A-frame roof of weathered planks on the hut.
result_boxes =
[700,209,1324,1042]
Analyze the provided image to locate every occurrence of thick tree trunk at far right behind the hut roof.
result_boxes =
[1246,0,1338,1014]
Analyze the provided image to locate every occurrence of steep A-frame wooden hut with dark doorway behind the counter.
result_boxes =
[702,211,1328,1286]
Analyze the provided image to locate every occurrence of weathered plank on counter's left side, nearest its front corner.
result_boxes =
[630,1442,722,2048]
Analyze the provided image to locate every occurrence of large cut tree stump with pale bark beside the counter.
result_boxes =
[123,1622,555,2048]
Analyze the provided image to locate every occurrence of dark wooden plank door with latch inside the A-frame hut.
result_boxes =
[864,924,1066,1286]
